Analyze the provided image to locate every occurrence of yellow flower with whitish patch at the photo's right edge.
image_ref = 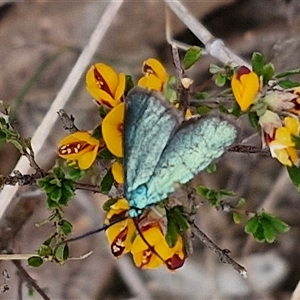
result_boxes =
[268,117,300,167]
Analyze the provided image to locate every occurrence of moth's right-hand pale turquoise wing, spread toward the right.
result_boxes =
[147,117,238,204]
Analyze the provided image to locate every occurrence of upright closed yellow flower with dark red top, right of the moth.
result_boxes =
[231,66,259,111]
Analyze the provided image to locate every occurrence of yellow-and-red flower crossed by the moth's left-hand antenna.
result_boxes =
[104,198,136,258]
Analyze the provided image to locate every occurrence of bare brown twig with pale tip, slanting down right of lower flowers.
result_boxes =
[192,223,247,278]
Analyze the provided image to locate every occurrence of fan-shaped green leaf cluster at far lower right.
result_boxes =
[245,211,290,243]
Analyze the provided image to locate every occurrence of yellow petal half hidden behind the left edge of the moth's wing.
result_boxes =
[101,103,125,157]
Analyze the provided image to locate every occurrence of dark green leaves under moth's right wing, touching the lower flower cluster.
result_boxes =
[166,206,190,248]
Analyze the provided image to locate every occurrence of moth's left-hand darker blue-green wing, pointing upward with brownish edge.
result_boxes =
[123,87,183,199]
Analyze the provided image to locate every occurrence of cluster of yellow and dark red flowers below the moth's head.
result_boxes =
[104,198,186,270]
